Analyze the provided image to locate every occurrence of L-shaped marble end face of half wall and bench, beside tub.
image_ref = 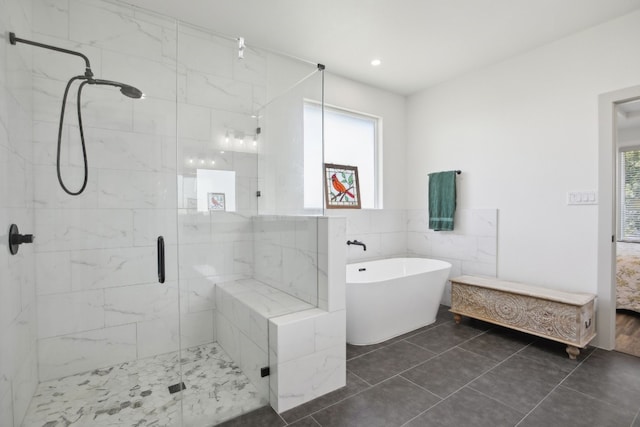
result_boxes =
[269,217,346,412]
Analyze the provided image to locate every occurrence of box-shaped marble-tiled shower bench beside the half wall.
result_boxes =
[216,279,346,412]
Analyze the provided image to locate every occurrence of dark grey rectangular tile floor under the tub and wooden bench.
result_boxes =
[222,307,640,427]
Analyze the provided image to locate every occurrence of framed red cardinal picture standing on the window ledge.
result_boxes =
[324,163,360,209]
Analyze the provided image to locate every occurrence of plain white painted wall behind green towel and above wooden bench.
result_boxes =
[406,11,640,300]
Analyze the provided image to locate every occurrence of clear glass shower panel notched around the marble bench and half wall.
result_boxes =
[177,18,322,426]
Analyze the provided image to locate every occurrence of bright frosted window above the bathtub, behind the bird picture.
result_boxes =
[304,102,382,209]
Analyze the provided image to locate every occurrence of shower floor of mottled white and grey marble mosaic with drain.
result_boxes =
[23,343,268,427]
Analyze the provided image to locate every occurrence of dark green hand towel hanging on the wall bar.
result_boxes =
[429,171,456,231]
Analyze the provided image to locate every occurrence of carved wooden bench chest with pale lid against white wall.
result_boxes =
[449,276,596,359]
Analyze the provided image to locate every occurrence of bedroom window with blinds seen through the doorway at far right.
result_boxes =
[619,147,640,241]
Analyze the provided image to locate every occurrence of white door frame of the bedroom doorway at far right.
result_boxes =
[594,86,640,350]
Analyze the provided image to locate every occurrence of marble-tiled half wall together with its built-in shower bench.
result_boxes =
[216,216,346,412]
